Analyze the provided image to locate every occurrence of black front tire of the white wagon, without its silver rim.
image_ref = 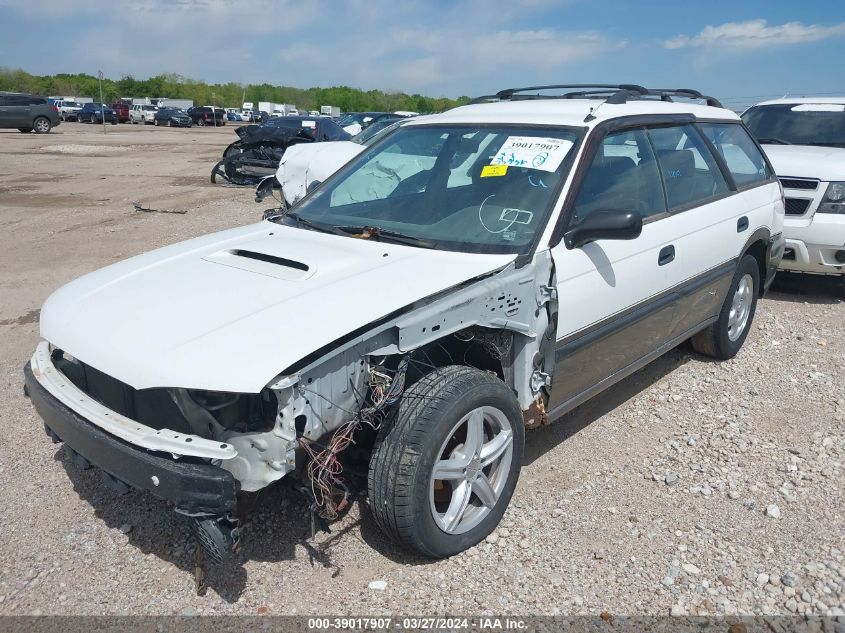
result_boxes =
[368,365,525,558]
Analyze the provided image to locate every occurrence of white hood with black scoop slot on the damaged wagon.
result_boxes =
[41,221,515,393]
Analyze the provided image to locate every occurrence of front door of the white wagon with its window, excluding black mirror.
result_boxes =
[548,126,677,414]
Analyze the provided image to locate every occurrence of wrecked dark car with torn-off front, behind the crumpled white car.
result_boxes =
[211,116,350,186]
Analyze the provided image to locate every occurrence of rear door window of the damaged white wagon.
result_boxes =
[648,125,728,211]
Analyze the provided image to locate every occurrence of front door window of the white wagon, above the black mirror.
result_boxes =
[573,129,666,224]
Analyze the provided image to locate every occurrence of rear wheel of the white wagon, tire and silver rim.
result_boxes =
[692,255,760,360]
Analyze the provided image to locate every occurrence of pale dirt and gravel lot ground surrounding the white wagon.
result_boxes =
[0,123,845,615]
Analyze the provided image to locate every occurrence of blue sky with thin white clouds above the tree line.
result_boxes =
[0,0,845,107]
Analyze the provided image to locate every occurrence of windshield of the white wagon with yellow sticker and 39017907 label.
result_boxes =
[277,126,579,253]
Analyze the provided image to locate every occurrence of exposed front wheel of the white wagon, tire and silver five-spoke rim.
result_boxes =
[368,365,524,558]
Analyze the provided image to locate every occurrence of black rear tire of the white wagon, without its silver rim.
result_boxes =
[691,255,760,360]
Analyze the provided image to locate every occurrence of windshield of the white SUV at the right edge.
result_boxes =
[742,103,845,147]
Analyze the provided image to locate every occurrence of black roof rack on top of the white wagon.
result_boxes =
[470,84,723,108]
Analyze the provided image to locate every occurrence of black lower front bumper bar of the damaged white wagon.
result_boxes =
[24,363,238,515]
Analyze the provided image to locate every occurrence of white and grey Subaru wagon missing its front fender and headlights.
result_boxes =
[25,85,783,561]
